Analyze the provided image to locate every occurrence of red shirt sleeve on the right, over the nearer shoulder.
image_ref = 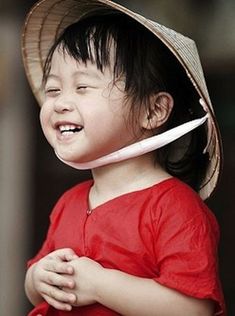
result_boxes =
[152,186,224,315]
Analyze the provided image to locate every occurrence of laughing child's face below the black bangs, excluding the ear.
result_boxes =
[40,50,142,162]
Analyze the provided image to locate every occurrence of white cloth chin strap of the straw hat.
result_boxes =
[55,114,209,170]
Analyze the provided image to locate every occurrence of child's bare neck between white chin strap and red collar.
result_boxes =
[89,154,171,209]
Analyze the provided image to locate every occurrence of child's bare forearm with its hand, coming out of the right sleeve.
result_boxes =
[65,257,213,316]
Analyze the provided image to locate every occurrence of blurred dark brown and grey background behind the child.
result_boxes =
[0,0,235,316]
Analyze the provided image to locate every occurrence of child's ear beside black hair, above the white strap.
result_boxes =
[142,92,174,130]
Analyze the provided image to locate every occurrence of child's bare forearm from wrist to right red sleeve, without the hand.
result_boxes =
[93,270,214,316]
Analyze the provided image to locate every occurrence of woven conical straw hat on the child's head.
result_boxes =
[22,0,222,199]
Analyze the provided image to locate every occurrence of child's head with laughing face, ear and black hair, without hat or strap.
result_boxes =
[38,10,209,190]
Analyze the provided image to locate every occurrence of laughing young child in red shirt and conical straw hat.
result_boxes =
[22,0,225,316]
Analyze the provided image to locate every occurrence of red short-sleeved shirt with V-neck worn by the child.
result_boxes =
[29,178,225,316]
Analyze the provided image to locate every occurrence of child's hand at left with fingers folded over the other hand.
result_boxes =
[25,249,76,310]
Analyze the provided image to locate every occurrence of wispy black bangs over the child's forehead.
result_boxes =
[43,15,126,83]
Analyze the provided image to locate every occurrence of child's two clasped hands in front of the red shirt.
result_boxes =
[32,248,103,311]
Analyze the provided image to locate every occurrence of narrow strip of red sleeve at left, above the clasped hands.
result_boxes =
[27,194,65,268]
